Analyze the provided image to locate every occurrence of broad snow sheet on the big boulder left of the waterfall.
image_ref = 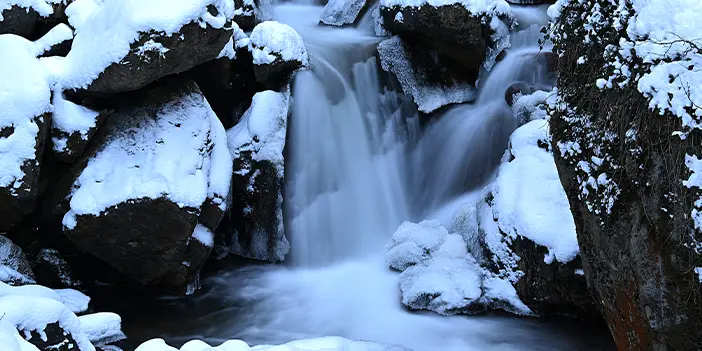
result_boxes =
[63,84,232,229]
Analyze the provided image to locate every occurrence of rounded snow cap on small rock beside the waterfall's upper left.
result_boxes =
[249,21,309,66]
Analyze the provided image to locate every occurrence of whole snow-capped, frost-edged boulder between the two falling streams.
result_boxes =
[379,0,514,113]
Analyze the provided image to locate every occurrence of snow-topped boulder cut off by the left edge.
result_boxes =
[0,34,52,231]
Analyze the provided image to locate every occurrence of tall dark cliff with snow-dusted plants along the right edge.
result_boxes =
[550,0,702,350]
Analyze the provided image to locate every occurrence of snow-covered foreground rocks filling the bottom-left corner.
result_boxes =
[0,282,125,351]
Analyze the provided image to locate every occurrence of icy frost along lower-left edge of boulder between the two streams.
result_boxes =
[378,36,476,113]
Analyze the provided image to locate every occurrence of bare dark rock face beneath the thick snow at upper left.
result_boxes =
[86,17,232,95]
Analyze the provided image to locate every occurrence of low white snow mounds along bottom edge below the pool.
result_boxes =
[135,336,409,351]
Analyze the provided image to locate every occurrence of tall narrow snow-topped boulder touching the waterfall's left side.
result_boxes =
[220,90,290,262]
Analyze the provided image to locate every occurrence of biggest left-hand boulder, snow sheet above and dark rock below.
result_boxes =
[44,79,232,287]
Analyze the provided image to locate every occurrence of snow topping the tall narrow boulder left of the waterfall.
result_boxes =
[227,90,290,178]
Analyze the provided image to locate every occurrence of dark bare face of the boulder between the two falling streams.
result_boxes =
[380,5,490,85]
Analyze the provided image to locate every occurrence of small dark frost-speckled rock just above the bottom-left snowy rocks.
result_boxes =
[34,249,83,289]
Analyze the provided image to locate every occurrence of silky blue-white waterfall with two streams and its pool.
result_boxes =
[103,4,610,351]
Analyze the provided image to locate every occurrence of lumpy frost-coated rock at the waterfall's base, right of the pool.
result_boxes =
[386,220,531,315]
